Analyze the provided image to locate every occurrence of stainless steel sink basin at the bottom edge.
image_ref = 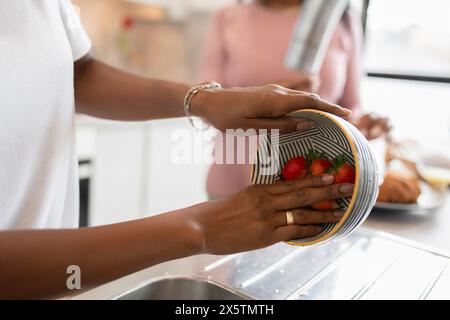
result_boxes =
[115,277,250,300]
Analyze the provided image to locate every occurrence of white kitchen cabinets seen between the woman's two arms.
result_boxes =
[78,117,208,226]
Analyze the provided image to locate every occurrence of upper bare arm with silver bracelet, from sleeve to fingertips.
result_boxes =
[75,54,351,133]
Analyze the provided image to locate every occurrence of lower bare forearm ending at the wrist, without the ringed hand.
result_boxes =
[0,207,203,299]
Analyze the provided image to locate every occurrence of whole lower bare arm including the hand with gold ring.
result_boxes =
[0,175,353,299]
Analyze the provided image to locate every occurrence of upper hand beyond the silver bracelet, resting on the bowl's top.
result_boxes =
[191,84,351,133]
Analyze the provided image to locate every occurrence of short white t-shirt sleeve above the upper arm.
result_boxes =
[59,0,92,61]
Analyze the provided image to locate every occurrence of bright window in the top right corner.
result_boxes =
[366,0,450,82]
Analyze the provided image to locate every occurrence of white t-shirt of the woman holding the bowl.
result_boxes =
[0,0,91,230]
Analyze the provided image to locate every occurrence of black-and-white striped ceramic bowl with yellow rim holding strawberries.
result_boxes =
[251,110,378,246]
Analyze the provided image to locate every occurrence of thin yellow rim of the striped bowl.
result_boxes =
[250,109,360,247]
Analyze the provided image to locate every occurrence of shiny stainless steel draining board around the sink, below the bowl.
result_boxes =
[72,228,450,300]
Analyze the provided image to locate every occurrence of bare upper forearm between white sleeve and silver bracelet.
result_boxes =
[75,57,189,121]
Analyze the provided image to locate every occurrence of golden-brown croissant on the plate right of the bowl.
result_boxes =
[377,170,421,203]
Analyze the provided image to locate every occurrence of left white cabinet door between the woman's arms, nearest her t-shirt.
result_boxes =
[77,117,143,226]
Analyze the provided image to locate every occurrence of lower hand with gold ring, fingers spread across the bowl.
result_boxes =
[192,175,353,254]
